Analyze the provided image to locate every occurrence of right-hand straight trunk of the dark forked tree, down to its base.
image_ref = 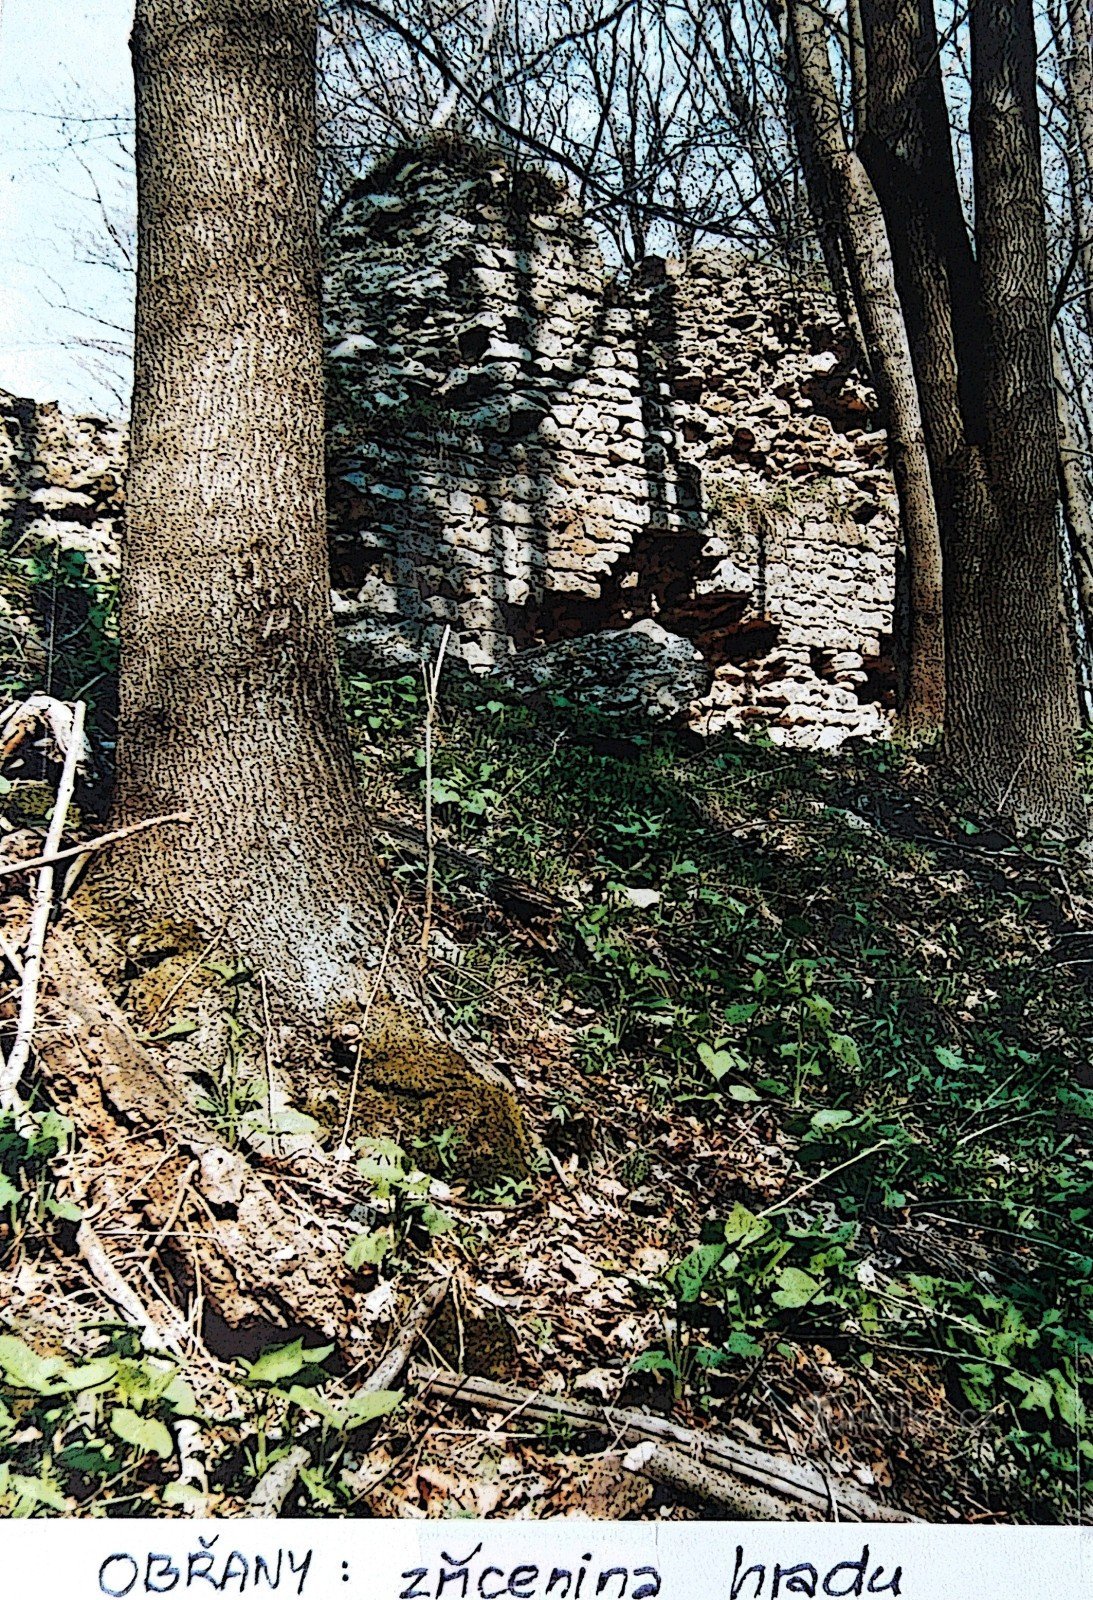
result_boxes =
[947,0,1079,826]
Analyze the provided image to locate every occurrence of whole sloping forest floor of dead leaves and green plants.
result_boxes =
[0,566,1093,1522]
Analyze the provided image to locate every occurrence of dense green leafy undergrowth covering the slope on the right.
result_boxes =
[347,677,1093,1522]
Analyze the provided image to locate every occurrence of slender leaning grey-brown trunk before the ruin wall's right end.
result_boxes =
[777,0,946,738]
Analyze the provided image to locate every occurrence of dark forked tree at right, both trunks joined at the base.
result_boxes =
[861,0,1080,829]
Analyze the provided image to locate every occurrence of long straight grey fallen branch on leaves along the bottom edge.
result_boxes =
[411,1366,922,1522]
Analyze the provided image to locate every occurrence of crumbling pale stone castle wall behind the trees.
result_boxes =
[0,152,896,747]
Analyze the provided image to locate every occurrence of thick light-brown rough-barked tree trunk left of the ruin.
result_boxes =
[117,0,395,1011]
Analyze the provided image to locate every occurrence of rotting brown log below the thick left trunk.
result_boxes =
[38,930,352,1355]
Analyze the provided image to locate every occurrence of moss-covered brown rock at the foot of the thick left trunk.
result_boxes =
[307,1003,530,1187]
